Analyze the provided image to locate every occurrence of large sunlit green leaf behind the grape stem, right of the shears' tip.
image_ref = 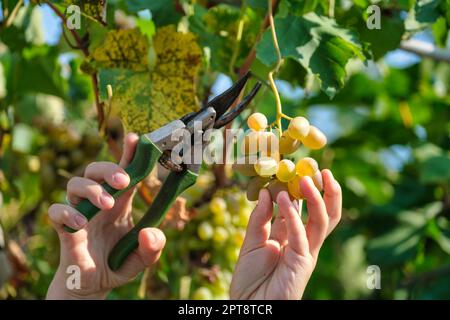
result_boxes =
[256,13,366,98]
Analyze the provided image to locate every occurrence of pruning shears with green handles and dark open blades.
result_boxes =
[66,72,261,270]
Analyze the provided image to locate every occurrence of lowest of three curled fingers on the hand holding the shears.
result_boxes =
[48,203,88,233]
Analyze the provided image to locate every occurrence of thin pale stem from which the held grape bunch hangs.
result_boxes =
[268,0,292,137]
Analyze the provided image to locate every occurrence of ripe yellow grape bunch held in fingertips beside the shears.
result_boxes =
[233,113,327,201]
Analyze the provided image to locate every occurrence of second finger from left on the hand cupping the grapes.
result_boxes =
[277,191,309,256]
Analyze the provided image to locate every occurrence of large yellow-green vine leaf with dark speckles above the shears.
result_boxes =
[100,26,202,133]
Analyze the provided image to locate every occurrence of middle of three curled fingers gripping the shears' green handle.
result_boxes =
[67,177,114,210]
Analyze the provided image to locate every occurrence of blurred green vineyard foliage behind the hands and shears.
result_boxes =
[0,0,450,299]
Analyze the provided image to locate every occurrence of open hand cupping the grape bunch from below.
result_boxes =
[230,170,342,299]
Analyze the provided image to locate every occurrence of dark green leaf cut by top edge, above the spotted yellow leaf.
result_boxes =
[125,0,181,27]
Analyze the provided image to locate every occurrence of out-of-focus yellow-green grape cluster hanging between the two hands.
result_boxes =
[190,188,254,299]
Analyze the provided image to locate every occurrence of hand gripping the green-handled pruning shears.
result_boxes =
[47,134,166,299]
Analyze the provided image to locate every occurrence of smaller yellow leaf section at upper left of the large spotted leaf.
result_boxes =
[82,28,149,73]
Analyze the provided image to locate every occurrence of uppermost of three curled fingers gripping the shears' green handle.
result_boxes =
[84,162,130,190]
